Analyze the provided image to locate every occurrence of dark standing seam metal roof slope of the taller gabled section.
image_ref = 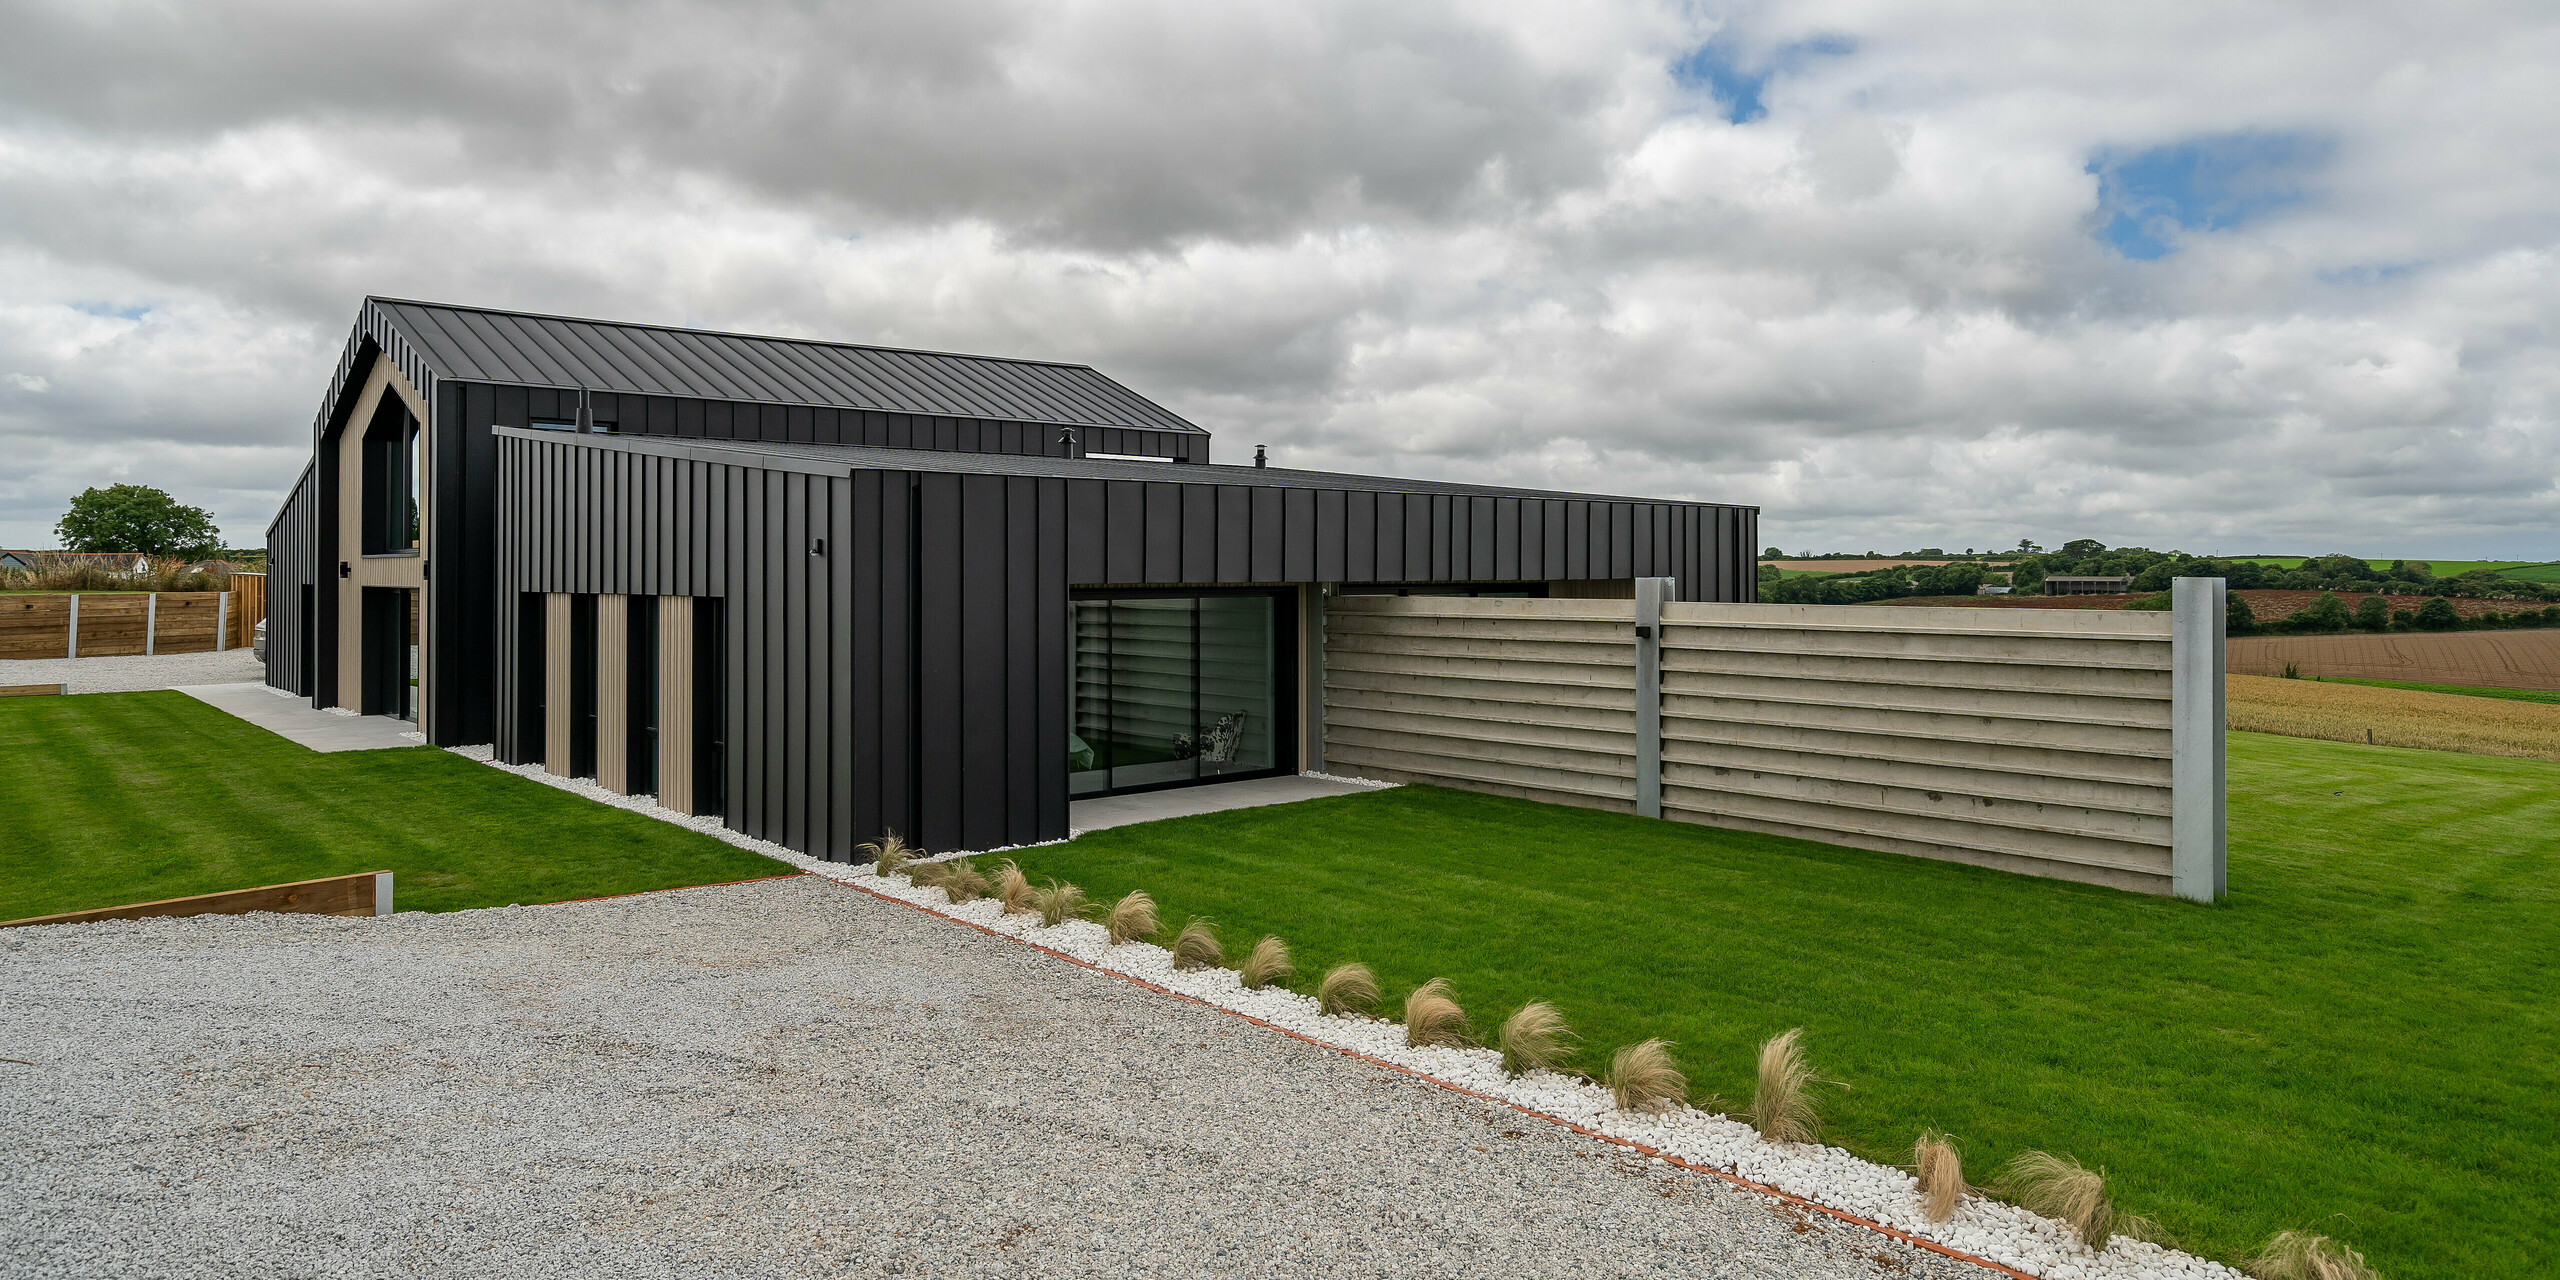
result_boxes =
[358,297,1208,435]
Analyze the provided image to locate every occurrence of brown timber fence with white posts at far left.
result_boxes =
[0,573,266,658]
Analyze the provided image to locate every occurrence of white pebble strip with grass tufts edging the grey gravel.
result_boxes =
[448,745,2248,1280]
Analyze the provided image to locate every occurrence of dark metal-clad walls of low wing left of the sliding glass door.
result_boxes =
[492,435,1068,860]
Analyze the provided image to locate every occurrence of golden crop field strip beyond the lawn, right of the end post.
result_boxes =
[2225,676,2560,760]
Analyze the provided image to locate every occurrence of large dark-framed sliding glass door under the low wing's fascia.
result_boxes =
[1068,591,1295,796]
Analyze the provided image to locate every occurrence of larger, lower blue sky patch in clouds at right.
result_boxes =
[2089,133,2332,261]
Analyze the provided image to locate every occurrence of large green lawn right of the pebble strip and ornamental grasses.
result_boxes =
[1019,735,2560,1280]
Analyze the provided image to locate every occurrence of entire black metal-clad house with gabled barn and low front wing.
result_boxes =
[266,300,1759,860]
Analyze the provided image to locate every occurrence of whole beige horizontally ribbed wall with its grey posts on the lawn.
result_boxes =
[1324,579,2225,901]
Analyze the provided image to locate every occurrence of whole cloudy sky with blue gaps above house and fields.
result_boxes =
[0,0,2560,558]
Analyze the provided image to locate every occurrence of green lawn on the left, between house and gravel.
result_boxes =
[0,694,791,919]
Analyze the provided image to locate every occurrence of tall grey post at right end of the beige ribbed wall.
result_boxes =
[2168,579,2230,901]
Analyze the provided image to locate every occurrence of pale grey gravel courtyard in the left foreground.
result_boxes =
[0,878,1987,1280]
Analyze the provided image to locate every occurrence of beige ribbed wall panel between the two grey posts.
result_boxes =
[1661,604,2173,893]
